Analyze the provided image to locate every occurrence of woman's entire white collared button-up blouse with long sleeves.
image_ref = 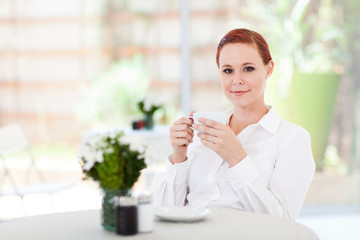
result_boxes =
[152,107,315,219]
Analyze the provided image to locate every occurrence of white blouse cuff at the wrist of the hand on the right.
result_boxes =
[227,155,260,189]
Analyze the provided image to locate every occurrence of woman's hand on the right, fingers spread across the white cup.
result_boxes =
[192,118,247,167]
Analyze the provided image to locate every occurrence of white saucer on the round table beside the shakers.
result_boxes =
[155,207,211,222]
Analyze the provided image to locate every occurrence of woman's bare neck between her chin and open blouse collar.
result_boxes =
[229,104,268,135]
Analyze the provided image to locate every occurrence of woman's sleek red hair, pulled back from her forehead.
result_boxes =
[216,28,272,67]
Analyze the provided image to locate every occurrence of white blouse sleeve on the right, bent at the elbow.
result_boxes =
[227,128,315,219]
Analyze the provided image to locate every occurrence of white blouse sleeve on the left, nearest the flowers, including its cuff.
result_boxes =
[152,156,188,207]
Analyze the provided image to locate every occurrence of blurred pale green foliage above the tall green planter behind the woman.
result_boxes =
[231,0,349,100]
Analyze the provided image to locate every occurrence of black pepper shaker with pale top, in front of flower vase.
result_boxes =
[114,196,137,236]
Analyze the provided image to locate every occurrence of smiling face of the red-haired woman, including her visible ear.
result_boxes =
[219,43,274,109]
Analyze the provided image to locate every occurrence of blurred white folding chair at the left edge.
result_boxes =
[0,124,73,213]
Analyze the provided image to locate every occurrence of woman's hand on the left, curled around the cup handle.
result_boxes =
[170,117,194,164]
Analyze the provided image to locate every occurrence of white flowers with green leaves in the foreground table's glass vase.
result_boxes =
[80,131,151,189]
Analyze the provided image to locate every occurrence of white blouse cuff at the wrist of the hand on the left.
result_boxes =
[166,156,188,185]
